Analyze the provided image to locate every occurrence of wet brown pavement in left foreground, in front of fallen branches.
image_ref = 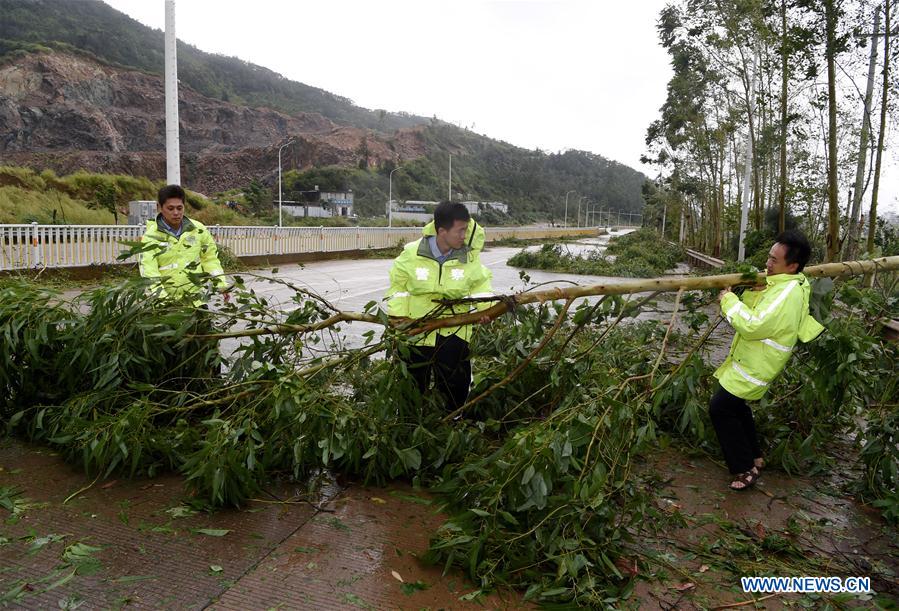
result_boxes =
[0,439,521,611]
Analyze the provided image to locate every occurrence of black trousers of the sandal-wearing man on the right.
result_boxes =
[709,388,762,474]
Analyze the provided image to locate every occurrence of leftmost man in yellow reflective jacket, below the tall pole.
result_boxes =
[140,185,230,305]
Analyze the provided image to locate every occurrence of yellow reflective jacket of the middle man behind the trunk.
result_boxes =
[386,220,493,346]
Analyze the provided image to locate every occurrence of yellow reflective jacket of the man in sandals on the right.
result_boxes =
[715,274,824,400]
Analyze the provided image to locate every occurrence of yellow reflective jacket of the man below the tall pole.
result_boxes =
[140,216,227,299]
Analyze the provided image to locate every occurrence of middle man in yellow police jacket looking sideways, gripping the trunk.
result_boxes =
[386,202,492,410]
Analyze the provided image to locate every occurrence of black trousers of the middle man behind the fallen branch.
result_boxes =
[407,334,471,411]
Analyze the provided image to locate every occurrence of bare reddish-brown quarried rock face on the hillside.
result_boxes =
[0,52,425,193]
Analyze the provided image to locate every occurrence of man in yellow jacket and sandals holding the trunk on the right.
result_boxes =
[709,230,824,490]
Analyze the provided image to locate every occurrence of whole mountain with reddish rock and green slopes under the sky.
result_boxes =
[0,0,646,221]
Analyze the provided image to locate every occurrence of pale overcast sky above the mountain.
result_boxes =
[104,0,899,215]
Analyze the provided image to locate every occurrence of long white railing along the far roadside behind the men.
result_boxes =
[0,224,624,271]
